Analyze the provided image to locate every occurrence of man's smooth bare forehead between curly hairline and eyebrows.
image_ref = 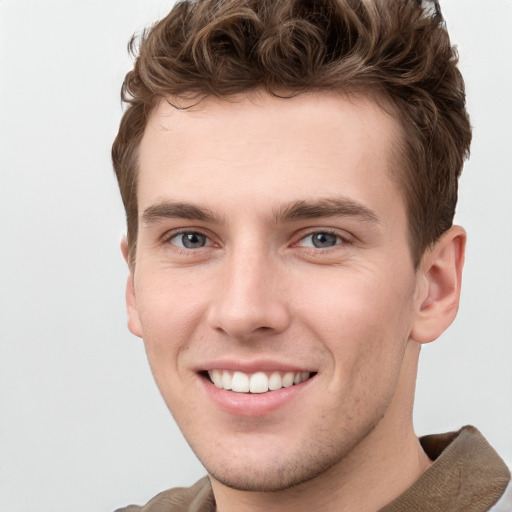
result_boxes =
[138,93,401,222]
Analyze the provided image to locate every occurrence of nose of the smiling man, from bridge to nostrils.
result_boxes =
[208,251,290,340]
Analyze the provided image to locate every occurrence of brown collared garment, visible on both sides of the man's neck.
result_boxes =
[116,426,512,512]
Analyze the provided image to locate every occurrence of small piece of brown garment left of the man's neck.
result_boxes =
[115,477,215,512]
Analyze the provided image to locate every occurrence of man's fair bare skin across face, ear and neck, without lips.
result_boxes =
[123,93,465,512]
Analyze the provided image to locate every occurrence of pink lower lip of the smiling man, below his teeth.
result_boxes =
[199,376,315,416]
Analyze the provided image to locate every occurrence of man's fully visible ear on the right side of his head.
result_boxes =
[411,226,466,343]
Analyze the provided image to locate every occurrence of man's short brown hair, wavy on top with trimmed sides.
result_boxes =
[112,0,471,265]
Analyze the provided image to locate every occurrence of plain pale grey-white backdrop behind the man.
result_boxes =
[0,0,512,512]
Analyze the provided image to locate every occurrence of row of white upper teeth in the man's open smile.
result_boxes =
[208,370,310,393]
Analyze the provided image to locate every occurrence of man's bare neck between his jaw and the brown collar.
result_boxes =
[211,342,430,512]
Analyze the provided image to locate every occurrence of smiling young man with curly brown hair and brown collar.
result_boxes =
[113,0,510,512]
